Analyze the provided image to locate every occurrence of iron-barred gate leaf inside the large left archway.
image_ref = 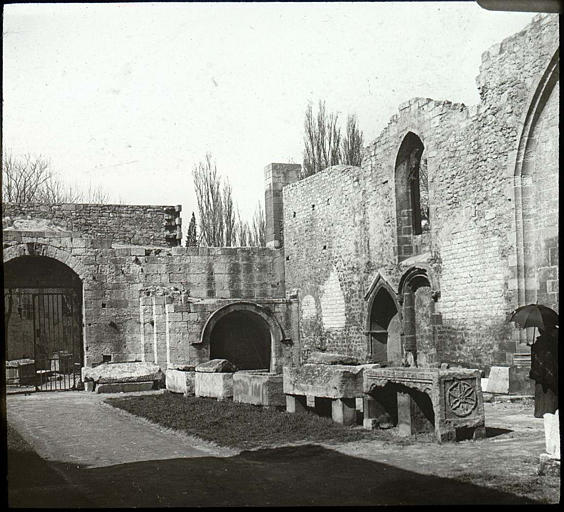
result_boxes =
[32,290,83,391]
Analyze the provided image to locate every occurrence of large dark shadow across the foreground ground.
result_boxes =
[8,445,534,507]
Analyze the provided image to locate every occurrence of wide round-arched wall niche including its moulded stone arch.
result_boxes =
[200,302,284,372]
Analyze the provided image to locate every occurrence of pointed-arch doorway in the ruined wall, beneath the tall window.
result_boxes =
[368,287,402,364]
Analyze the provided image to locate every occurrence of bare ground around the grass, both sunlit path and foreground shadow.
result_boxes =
[7,392,560,507]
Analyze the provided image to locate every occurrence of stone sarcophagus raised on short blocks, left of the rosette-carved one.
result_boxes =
[283,363,378,425]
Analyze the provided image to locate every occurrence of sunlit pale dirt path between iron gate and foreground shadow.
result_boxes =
[7,391,236,467]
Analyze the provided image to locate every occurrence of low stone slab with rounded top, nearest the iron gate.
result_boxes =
[82,362,164,393]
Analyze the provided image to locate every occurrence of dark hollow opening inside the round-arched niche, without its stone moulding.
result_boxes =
[210,310,271,371]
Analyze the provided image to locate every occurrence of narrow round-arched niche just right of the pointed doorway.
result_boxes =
[398,265,440,366]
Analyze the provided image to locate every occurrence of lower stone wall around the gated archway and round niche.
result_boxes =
[3,230,298,367]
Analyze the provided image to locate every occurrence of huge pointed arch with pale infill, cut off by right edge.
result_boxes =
[514,50,560,332]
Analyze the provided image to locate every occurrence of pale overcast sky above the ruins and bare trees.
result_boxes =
[3,2,534,225]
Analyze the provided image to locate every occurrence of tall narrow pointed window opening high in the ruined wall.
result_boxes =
[395,131,430,261]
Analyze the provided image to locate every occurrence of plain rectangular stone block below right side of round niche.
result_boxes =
[233,370,286,407]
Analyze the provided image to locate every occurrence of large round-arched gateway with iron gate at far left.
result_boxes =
[4,255,84,390]
